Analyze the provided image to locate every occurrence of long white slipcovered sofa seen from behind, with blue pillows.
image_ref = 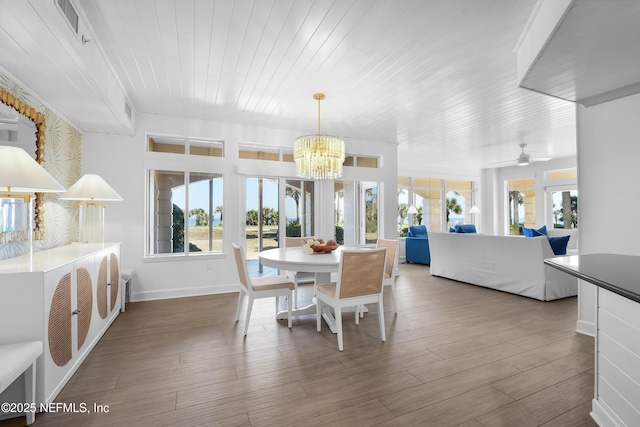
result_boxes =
[429,233,578,301]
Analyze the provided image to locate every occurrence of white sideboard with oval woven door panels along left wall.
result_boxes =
[0,243,122,418]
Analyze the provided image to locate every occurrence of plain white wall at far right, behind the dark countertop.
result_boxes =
[577,95,640,334]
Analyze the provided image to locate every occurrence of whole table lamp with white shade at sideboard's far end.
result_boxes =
[60,174,122,243]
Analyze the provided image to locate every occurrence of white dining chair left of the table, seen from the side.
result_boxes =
[232,243,294,335]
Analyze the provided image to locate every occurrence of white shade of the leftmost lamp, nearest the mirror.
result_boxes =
[0,146,65,194]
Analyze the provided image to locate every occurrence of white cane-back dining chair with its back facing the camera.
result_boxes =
[316,248,387,351]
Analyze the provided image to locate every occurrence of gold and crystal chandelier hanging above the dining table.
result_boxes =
[293,93,344,179]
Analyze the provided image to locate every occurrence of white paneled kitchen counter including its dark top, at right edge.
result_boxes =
[544,254,640,427]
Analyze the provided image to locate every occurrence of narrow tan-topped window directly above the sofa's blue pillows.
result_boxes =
[507,178,536,235]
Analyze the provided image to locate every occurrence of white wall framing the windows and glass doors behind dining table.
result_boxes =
[82,115,398,301]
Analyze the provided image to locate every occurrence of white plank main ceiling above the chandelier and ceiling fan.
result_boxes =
[0,0,576,168]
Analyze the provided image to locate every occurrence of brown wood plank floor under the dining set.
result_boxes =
[0,264,596,427]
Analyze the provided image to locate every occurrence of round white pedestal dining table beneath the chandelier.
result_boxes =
[258,246,369,333]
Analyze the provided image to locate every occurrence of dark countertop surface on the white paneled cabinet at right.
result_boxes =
[544,254,640,303]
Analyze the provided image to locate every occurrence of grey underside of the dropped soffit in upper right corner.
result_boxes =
[520,0,640,106]
